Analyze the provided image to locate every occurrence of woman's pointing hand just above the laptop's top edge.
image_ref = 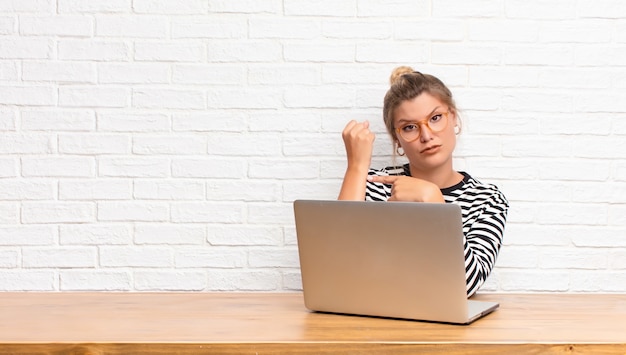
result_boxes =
[367,175,445,202]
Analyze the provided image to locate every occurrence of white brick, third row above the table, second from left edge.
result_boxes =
[59,223,132,245]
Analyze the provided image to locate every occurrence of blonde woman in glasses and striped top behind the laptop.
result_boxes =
[339,67,509,297]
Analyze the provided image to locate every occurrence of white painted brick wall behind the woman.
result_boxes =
[0,0,626,292]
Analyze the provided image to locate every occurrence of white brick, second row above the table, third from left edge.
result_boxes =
[100,246,174,267]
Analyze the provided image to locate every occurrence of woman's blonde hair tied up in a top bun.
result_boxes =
[383,66,460,149]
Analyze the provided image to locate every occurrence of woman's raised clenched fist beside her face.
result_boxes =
[341,120,375,171]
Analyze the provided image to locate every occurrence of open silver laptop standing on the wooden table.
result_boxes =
[294,200,498,324]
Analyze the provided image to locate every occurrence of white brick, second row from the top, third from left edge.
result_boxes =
[95,15,169,38]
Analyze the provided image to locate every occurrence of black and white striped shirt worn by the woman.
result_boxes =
[365,164,509,297]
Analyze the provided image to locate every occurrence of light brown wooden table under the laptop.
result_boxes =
[0,293,626,354]
